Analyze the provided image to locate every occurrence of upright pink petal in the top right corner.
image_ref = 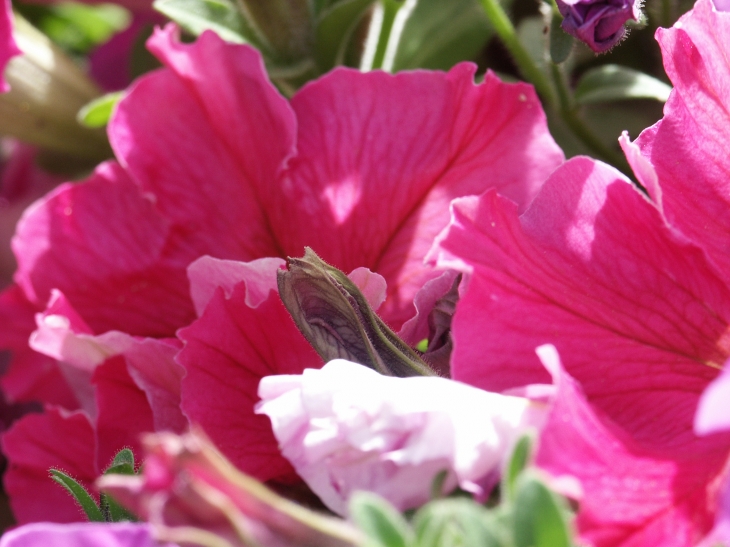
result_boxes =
[636,0,730,275]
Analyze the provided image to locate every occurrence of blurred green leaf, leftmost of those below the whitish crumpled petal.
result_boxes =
[350,492,413,547]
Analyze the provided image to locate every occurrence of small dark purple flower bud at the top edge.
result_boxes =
[557,0,641,53]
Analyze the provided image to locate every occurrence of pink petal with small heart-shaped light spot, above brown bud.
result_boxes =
[272,64,563,328]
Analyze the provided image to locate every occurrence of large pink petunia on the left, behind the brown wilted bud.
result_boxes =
[1,17,563,524]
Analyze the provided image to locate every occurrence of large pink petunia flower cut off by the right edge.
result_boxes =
[434,0,730,546]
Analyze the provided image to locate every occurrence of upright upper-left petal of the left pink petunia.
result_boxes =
[109,25,295,261]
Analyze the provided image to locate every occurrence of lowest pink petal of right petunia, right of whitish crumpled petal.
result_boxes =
[536,348,730,547]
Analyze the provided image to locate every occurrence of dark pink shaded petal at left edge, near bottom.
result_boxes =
[2,408,97,524]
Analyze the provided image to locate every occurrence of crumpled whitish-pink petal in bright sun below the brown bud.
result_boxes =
[256,359,548,514]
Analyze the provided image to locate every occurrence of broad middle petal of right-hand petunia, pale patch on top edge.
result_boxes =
[436,158,730,545]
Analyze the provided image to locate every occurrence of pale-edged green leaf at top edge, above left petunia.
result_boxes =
[152,0,250,47]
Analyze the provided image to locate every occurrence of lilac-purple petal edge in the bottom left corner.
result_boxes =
[0,522,171,547]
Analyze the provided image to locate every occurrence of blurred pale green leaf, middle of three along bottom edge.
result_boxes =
[413,498,509,547]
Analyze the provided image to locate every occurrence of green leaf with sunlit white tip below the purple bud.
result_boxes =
[575,65,672,104]
